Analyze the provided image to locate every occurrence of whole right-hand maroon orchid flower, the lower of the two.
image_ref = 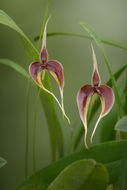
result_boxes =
[77,46,115,148]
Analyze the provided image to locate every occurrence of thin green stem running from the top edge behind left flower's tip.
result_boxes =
[37,0,50,50]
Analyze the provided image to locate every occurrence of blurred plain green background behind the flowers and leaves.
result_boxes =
[0,0,127,190]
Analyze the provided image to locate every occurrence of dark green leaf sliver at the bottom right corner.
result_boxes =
[117,146,127,190]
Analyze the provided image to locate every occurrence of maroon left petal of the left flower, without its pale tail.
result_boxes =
[29,62,43,85]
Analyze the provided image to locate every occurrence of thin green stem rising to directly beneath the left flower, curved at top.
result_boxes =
[33,88,41,174]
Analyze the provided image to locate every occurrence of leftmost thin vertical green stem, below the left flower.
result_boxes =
[25,79,30,179]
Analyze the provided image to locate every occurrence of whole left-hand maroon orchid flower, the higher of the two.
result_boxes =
[29,19,70,123]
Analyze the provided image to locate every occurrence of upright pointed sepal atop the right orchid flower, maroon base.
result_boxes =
[91,44,100,86]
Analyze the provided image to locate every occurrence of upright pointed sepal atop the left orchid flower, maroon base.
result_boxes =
[40,18,50,62]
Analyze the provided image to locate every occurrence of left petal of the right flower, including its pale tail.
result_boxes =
[77,85,94,148]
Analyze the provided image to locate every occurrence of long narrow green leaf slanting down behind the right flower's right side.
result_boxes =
[80,23,123,117]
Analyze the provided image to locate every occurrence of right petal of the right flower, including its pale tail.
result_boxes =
[91,85,115,142]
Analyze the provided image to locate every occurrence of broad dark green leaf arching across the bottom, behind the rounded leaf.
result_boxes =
[17,140,127,190]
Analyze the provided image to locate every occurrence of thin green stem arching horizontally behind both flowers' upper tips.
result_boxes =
[34,32,127,50]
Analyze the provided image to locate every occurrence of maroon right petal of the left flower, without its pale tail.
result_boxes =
[47,60,64,89]
